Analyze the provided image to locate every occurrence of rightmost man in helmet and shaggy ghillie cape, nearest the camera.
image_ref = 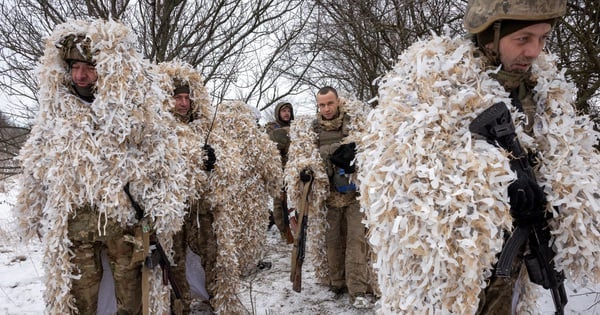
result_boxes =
[358,0,600,314]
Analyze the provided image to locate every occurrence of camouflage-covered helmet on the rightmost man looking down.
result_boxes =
[463,0,567,34]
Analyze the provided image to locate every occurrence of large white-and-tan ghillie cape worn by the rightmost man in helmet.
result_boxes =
[358,36,600,314]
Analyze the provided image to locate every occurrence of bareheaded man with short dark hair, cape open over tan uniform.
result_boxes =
[285,86,372,308]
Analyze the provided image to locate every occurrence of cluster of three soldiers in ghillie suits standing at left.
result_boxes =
[17,20,282,314]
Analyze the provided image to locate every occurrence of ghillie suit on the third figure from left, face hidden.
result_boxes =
[208,102,283,314]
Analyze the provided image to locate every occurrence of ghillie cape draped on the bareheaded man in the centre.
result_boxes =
[284,97,365,285]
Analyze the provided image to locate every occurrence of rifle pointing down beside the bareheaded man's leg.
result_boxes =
[290,173,313,292]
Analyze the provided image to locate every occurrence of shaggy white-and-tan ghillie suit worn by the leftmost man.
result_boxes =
[15,20,187,314]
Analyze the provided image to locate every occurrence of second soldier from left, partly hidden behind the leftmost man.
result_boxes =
[159,62,217,314]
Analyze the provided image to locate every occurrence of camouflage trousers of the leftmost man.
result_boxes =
[68,211,142,314]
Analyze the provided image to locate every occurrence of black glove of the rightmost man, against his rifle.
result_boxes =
[508,175,547,226]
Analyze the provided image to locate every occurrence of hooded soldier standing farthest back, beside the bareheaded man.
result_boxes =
[266,102,294,244]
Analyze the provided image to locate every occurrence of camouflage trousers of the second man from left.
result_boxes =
[172,202,217,314]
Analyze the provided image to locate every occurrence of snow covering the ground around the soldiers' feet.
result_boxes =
[0,178,600,315]
